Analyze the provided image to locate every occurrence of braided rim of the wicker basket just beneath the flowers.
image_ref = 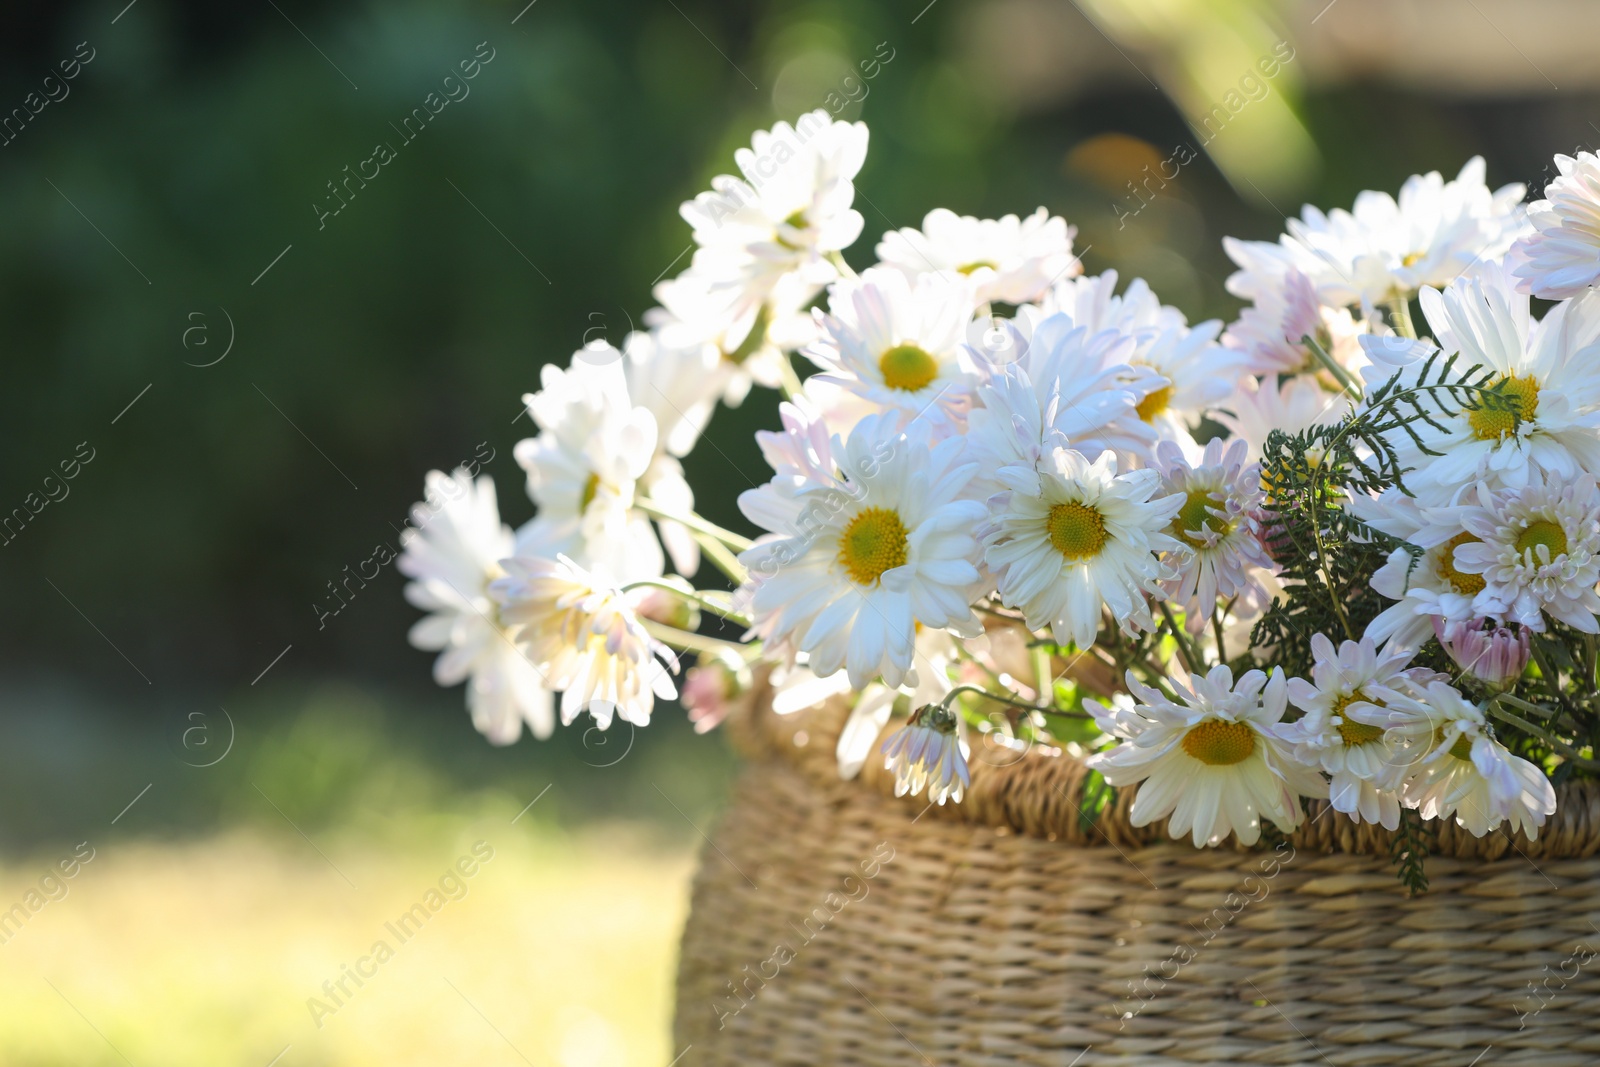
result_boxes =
[728,677,1600,861]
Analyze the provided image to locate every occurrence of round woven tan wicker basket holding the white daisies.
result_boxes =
[675,687,1600,1067]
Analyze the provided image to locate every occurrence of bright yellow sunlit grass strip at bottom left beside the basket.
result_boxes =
[0,805,691,1067]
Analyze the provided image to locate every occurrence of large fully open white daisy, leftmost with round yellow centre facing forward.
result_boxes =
[739,414,984,689]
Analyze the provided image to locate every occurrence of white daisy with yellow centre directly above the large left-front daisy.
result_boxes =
[805,267,976,424]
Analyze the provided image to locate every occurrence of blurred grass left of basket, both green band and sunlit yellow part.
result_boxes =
[0,685,731,1067]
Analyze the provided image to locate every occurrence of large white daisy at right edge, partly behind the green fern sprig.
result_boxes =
[1369,267,1600,502]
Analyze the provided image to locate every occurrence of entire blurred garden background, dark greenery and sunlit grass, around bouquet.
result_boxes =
[0,0,1600,1065]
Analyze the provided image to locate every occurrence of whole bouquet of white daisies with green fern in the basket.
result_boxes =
[400,110,1600,888]
